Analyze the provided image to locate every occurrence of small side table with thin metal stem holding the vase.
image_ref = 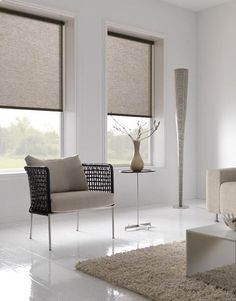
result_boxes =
[120,168,155,230]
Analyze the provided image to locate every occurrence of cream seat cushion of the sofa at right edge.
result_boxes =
[220,182,236,213]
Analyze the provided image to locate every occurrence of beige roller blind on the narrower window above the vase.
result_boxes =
[107,32,153,117]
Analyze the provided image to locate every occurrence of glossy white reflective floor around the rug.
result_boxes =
[0,201,218,301]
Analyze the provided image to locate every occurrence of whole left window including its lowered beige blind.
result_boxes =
[0,8,63,169]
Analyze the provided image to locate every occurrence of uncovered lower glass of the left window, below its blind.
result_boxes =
[0,109,61,169]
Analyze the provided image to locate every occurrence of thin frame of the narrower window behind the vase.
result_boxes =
[105,26,155,167]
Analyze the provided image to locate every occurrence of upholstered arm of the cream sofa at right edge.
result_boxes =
[206,168,236,213]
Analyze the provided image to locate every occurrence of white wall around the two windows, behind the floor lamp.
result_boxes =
[0,0,196,219]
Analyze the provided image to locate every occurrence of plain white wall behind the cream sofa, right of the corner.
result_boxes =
[197,1,236,198]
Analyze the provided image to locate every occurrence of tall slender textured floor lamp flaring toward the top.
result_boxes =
[174,69,188,209]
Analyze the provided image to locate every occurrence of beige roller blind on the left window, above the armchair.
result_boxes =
[0,9,63,111]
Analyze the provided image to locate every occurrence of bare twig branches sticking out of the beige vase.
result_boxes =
[111,116,160,141]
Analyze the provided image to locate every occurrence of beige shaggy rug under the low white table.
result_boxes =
[76,242,236,301]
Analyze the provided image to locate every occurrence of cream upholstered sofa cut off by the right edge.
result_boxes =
[206,168,236,222]
